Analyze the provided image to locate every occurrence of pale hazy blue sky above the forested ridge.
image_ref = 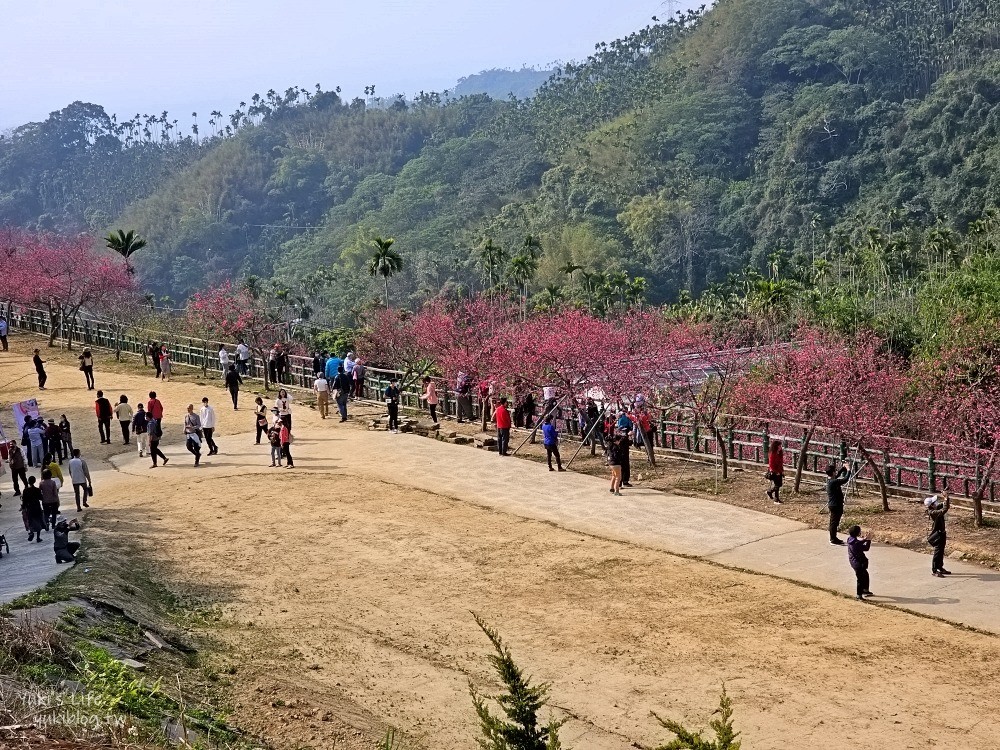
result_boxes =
[0,0,689,129]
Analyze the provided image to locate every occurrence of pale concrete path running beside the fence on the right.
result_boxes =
[342,432,1000,634]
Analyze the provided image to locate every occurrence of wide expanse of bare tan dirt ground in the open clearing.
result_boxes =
[0,338,1000,750]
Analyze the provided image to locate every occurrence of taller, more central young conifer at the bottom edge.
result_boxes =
[469,612,563,750]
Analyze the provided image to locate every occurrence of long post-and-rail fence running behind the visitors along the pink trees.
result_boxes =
[8,307,996,504]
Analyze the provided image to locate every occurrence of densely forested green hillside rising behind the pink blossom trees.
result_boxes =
[0,0,1000,323]
